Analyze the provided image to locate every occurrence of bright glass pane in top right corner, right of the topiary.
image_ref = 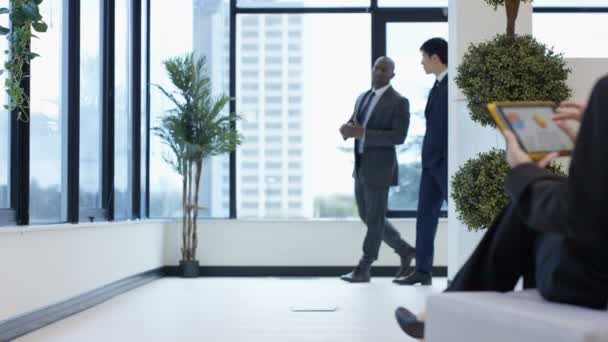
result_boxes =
[532,13,608,58]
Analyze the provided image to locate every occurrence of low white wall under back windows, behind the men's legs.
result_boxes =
[165,219,447,266]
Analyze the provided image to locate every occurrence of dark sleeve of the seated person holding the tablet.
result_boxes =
[505,163,575,237]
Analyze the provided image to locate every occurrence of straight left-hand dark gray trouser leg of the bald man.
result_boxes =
[355,177,388,265]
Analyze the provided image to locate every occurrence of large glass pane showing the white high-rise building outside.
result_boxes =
[236,14,371,218]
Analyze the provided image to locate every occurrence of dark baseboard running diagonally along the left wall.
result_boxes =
[0,267,165,341]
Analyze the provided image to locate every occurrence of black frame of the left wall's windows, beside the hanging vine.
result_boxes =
[0,0,150,226]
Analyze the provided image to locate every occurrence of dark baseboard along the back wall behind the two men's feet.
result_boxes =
[164,266,448,277]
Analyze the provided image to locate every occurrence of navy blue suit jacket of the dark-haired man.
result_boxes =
[422,75,448,168]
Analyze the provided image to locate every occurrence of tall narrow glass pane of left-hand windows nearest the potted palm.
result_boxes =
[114,1,133,220]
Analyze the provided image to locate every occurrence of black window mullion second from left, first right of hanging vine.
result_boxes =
[67,0,80,223]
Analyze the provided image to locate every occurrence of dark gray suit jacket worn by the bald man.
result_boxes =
[349,86,410,186]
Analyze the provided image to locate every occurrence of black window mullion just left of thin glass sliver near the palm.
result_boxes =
[131,0,142,218]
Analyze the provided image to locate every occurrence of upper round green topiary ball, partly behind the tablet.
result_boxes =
[455,34,572,127]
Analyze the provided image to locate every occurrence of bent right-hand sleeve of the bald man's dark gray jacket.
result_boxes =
[365,97,410,147]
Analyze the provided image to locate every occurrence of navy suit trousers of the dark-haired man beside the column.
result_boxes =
[416,168,445,273]
